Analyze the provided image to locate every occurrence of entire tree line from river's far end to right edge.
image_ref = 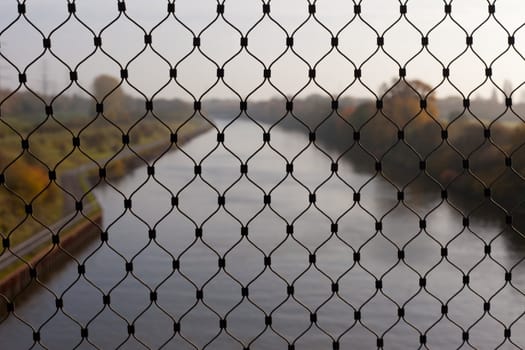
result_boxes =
[209,80,525,227]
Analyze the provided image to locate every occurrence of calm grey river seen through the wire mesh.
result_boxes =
[0,121,525,349]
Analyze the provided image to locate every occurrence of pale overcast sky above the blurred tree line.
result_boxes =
[0,0,525,99]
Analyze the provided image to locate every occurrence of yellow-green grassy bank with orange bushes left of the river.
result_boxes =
[0,117,208,252]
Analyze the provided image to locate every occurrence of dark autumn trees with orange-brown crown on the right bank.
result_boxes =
[330,80,525,216]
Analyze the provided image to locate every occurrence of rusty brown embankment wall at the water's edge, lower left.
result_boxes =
[0,210,102,304]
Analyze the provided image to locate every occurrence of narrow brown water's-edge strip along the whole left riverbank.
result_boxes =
[0,122,210,306]
